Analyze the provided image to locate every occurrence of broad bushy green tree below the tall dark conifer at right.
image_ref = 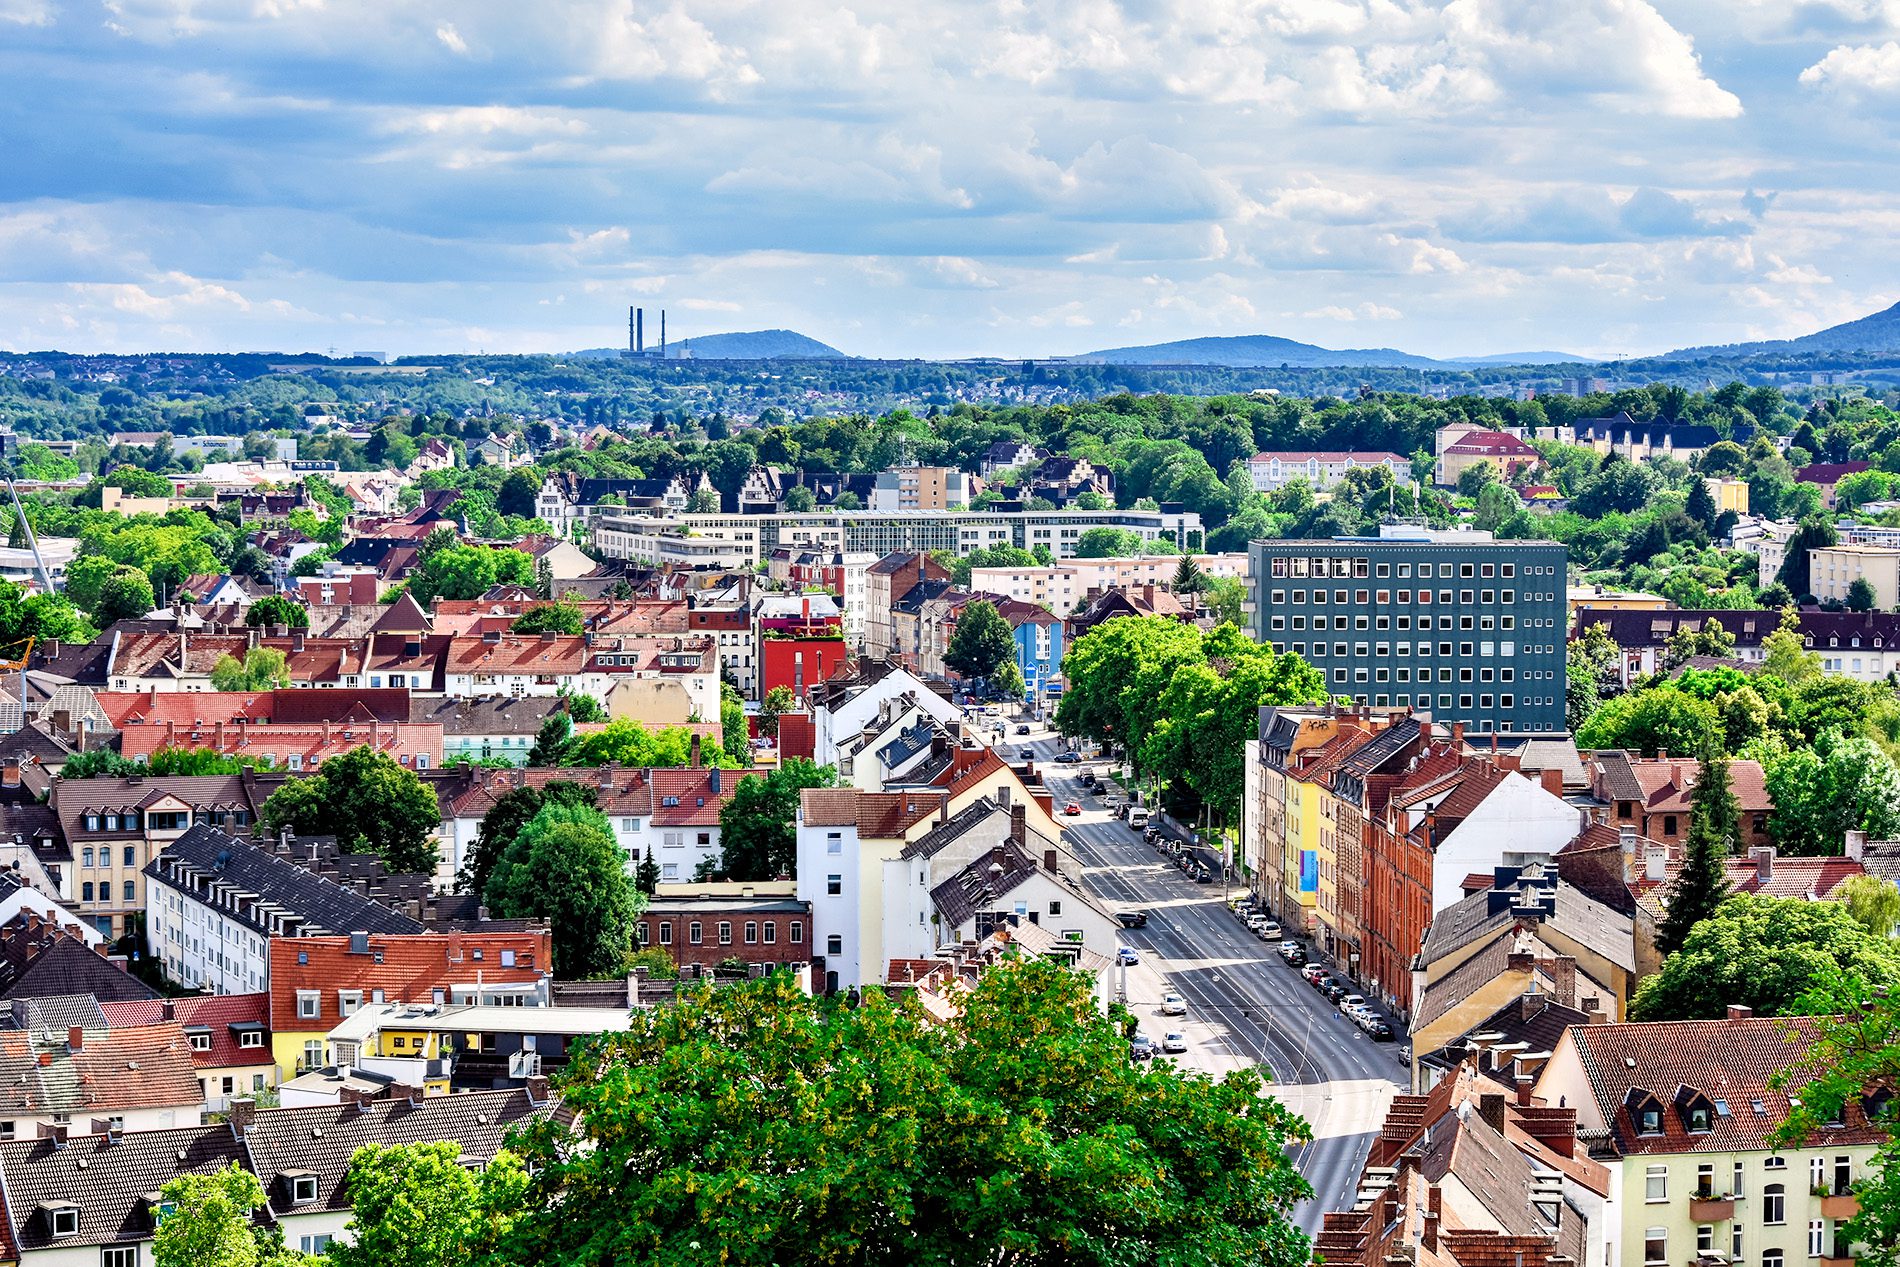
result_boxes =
[1630,895,1900,1020]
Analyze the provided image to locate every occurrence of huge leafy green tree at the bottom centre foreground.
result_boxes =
[500,961,1309,1267]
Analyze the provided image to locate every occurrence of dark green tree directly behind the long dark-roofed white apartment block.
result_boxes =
[264,745,443,876]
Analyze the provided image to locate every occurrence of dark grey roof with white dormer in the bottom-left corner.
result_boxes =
[0,1125,243,1250]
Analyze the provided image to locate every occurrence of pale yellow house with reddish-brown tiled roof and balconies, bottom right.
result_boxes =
[1535,1007,1887,1267]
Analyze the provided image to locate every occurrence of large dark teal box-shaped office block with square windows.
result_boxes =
[1250,528,1568,731]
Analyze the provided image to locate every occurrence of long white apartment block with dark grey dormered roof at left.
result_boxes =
[144,824,422,993]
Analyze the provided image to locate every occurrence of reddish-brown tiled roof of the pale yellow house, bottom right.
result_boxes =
[1564,1016,1887,1154]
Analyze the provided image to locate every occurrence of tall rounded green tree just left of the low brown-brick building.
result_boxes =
[483,802,642,980]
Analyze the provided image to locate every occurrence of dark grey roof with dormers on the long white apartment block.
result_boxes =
[144,823,424,935]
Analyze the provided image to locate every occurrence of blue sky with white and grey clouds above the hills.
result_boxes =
[0,0,1900,357]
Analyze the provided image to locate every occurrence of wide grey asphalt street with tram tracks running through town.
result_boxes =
[1011,724,1404,1231]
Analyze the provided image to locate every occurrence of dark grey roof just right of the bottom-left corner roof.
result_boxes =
[245,1088,551,1216]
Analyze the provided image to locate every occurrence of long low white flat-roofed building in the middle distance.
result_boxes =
[593,509,1201,568]
